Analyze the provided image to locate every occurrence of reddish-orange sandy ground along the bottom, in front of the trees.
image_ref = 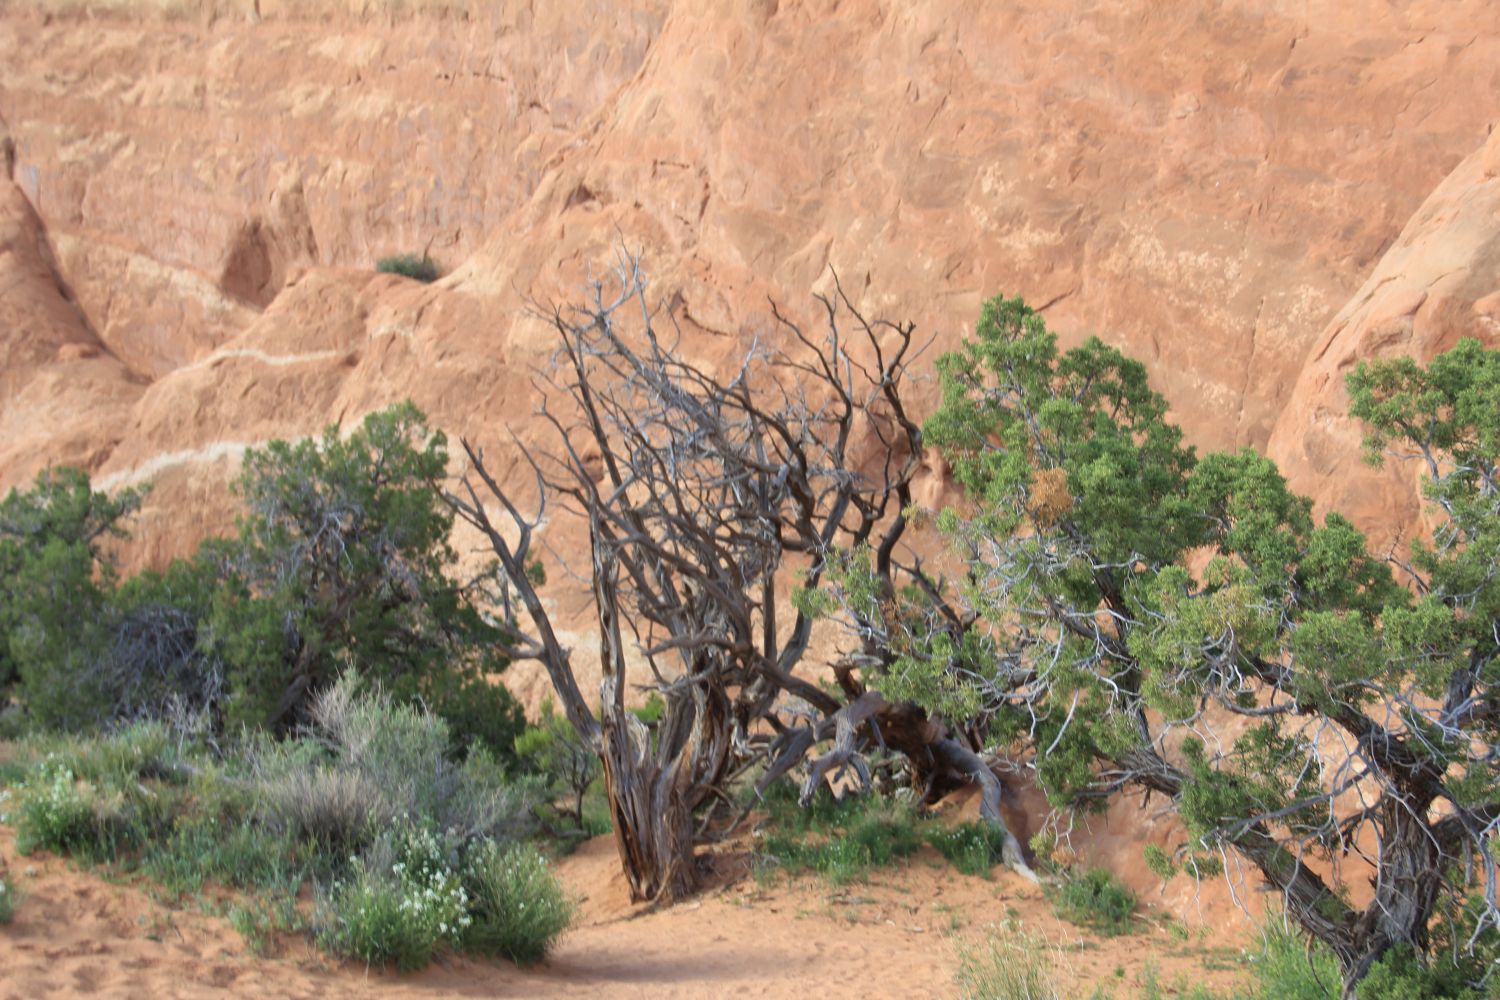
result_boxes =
[0,828,1251,1000]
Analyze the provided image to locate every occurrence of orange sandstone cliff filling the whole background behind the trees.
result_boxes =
[0,0,1500,626]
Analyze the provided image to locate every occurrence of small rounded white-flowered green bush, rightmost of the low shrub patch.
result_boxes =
[464,840,573,966]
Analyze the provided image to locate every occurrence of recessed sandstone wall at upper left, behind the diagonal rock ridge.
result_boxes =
[0,3,660,378]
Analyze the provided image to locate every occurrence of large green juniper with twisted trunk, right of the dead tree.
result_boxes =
[894,298,1500,996]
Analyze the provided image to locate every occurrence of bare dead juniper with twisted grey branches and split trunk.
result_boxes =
[449,256,1038,900]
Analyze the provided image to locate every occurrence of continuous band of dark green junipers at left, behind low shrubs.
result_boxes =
[0,403,524,759]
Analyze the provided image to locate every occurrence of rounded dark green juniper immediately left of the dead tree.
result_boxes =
[207,402,522,756]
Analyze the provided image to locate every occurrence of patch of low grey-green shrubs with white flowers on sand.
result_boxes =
[5,675,572,969]
